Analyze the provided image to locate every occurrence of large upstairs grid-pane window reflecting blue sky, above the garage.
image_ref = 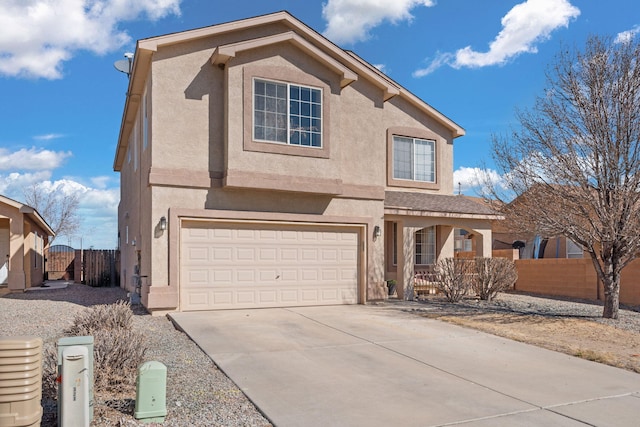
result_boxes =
[253,79,322,148]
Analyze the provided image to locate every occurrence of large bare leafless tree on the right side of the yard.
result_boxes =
[493,36,640,318]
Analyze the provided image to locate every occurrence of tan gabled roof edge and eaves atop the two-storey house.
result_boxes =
[113,11,465,171]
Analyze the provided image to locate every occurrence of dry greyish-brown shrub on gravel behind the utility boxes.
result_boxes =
[64,301,147,393]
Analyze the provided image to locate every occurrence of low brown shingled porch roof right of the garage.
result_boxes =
[384,191,500,219]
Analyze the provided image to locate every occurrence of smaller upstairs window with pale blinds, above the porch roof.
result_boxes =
[393,135,436,182]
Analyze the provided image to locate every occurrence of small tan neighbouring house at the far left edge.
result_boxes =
[0,196,54,291]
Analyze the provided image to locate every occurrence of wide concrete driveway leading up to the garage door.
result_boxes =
[170,305,640,427]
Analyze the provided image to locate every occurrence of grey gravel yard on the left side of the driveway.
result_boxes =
[0,285,271,427]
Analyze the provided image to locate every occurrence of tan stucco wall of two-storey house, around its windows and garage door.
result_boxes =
[119,18,462,308]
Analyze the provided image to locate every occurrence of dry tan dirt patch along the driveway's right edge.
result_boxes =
[425,313,640,373]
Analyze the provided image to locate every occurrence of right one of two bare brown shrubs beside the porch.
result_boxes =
[473,258,518,301]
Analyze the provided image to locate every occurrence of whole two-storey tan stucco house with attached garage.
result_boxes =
[114,12,497,312]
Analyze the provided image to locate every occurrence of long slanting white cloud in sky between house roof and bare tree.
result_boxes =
[414,0,580,77]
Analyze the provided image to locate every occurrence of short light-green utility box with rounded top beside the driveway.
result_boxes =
[133,361,167,423]
